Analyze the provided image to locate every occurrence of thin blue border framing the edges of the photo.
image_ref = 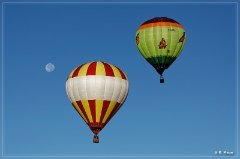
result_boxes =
[2,2,239,158]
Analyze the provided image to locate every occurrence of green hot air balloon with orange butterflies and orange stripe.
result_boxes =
[135,17,186,83]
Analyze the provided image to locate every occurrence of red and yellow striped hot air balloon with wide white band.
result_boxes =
[66,61,129,143]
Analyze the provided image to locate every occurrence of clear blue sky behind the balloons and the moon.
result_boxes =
[1,0,238,159]
